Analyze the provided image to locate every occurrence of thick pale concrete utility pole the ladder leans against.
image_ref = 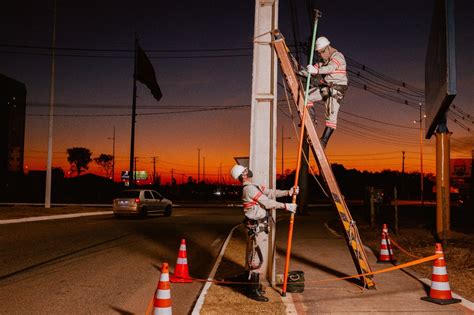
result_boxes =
[249,0,278,285]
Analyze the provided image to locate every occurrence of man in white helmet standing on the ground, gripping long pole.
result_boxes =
[230,165,299,302]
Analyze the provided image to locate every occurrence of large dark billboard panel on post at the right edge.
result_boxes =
[425,0,456,139]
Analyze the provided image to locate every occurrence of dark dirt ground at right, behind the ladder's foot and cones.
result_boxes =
[330,220,474,301]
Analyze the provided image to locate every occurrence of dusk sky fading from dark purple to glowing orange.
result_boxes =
[0,0,474,183]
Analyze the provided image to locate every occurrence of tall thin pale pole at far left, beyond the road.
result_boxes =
[44,0,57,208]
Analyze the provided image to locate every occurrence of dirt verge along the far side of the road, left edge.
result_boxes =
[0,206,112,220]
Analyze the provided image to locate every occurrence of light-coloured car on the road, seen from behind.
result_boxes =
[113,189,173,217]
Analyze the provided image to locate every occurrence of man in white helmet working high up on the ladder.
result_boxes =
[306,36,348,148]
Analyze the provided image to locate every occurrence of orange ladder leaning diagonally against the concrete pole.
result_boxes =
[273,30,375,289]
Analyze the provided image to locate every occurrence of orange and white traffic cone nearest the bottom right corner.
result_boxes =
[421,243,461,305]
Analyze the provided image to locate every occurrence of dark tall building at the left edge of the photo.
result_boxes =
[0,74,26,175]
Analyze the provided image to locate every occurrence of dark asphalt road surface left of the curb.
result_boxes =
[0,208,242,314]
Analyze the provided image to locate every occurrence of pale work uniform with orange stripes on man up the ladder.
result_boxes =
[308,50,348,129]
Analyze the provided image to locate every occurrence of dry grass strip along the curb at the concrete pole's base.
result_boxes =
[201,226,285,315]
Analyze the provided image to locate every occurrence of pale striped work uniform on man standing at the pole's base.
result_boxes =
[242,183,288,273]
